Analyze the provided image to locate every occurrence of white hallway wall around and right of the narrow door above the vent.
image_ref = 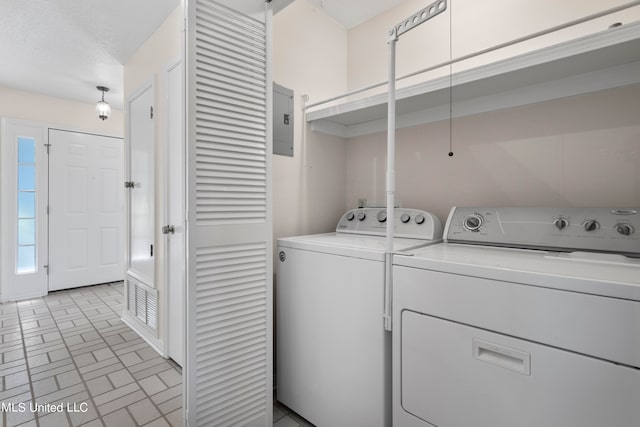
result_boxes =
[124,6,184,350]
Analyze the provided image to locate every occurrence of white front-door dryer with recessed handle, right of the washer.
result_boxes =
[393,208,640,427]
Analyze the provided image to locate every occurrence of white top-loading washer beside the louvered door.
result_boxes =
[276,208,442,427]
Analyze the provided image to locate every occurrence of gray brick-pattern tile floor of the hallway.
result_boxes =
[0,282,182,427]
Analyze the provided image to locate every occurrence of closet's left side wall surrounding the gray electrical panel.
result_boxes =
[273,0,347,241]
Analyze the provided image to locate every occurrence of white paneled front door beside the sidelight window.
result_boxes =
[49,129,125,291]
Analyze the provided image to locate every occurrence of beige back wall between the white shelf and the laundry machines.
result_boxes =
[347,85,640,221]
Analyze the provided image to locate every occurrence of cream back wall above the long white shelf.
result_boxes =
[348,0,640,94]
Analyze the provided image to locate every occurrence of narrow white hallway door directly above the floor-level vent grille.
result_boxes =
[127,85,155,287]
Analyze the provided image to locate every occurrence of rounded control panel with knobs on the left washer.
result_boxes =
[336,208,442,240]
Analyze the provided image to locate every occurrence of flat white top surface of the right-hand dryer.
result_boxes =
[393,243,640,301]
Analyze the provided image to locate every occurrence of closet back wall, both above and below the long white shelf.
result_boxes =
[346,0,640,224]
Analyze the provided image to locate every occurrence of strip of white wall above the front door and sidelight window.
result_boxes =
[0,86,124,138]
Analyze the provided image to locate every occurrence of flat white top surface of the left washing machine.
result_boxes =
[278,233,440,261]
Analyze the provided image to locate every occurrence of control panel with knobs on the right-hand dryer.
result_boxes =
[444,207,640,256]
